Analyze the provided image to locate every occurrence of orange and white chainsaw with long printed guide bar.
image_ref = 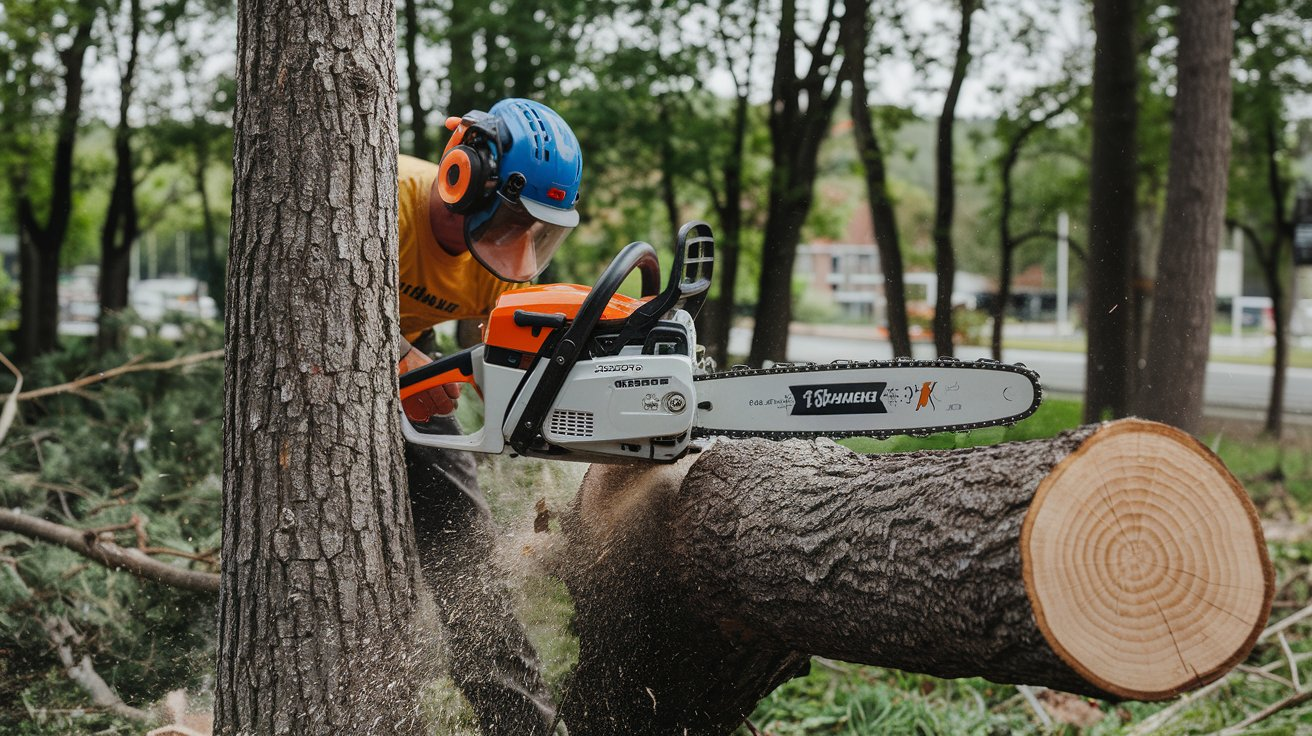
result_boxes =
[400,222,1042,462]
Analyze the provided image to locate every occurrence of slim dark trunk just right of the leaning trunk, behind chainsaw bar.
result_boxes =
[934,0,979,356]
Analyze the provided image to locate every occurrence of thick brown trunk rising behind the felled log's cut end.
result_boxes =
[1136,0,1235,432]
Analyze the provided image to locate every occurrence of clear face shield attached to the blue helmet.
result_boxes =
[464,193,573,282]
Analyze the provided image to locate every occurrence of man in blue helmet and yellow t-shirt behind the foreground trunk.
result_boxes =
[398,100,583,736]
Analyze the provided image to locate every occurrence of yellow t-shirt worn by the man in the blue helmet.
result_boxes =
[396,156,520,342]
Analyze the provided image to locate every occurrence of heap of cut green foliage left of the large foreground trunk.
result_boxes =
[0,330,223,733]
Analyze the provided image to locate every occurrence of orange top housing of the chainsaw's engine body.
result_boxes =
[483,283,651,354]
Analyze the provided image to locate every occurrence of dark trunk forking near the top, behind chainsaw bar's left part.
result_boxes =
[748,0,839,366]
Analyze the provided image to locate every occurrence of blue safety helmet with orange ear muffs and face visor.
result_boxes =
[438,98,583,282]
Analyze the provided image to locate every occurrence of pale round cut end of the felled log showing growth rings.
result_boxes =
[1021,420,1274,701]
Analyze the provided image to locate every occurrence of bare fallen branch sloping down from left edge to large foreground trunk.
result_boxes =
[0,509,219,593]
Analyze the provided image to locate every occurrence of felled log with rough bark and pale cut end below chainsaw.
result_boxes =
[558,420,1274,736]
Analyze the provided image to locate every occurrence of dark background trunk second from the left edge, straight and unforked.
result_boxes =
[96,0,142,354]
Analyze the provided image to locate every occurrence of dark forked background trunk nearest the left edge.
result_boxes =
[17,16,96,361]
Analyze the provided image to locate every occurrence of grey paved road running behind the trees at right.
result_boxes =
[729,328,1312,424]
